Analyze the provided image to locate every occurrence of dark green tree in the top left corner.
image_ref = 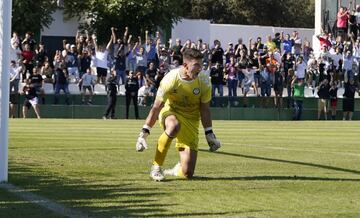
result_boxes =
[11,0,57,35]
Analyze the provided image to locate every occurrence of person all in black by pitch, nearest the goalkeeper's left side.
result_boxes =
[125,71,139,119]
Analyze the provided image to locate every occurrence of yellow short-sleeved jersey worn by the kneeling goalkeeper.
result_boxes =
[156,68,211,120]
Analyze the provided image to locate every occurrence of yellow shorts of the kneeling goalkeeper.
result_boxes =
[159,106,199,151]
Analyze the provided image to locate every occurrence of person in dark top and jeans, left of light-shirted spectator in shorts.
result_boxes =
[54,64,70,105]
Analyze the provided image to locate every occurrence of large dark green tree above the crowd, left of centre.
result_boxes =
[64,0,186,43]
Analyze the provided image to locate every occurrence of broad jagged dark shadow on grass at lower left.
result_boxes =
[5,163,258,217]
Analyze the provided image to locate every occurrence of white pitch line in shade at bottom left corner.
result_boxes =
[0,183,89,218]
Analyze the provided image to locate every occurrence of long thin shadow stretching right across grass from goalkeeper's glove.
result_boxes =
[199,149,360,174]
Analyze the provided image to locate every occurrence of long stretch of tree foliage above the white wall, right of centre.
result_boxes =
[185,0,315,28]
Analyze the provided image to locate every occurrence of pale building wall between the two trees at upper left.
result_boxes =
[41,9,79,37]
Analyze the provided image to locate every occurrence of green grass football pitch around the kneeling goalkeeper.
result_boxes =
[0,119,360,217]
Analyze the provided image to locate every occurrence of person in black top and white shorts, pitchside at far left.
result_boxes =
[22,80,40,119]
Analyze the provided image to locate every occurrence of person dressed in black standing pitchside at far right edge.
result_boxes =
[343,75,359,120]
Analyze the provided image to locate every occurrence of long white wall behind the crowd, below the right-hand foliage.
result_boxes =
[171,19,315,47]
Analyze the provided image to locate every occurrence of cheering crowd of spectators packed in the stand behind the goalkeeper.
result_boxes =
[10,6,360,119]
